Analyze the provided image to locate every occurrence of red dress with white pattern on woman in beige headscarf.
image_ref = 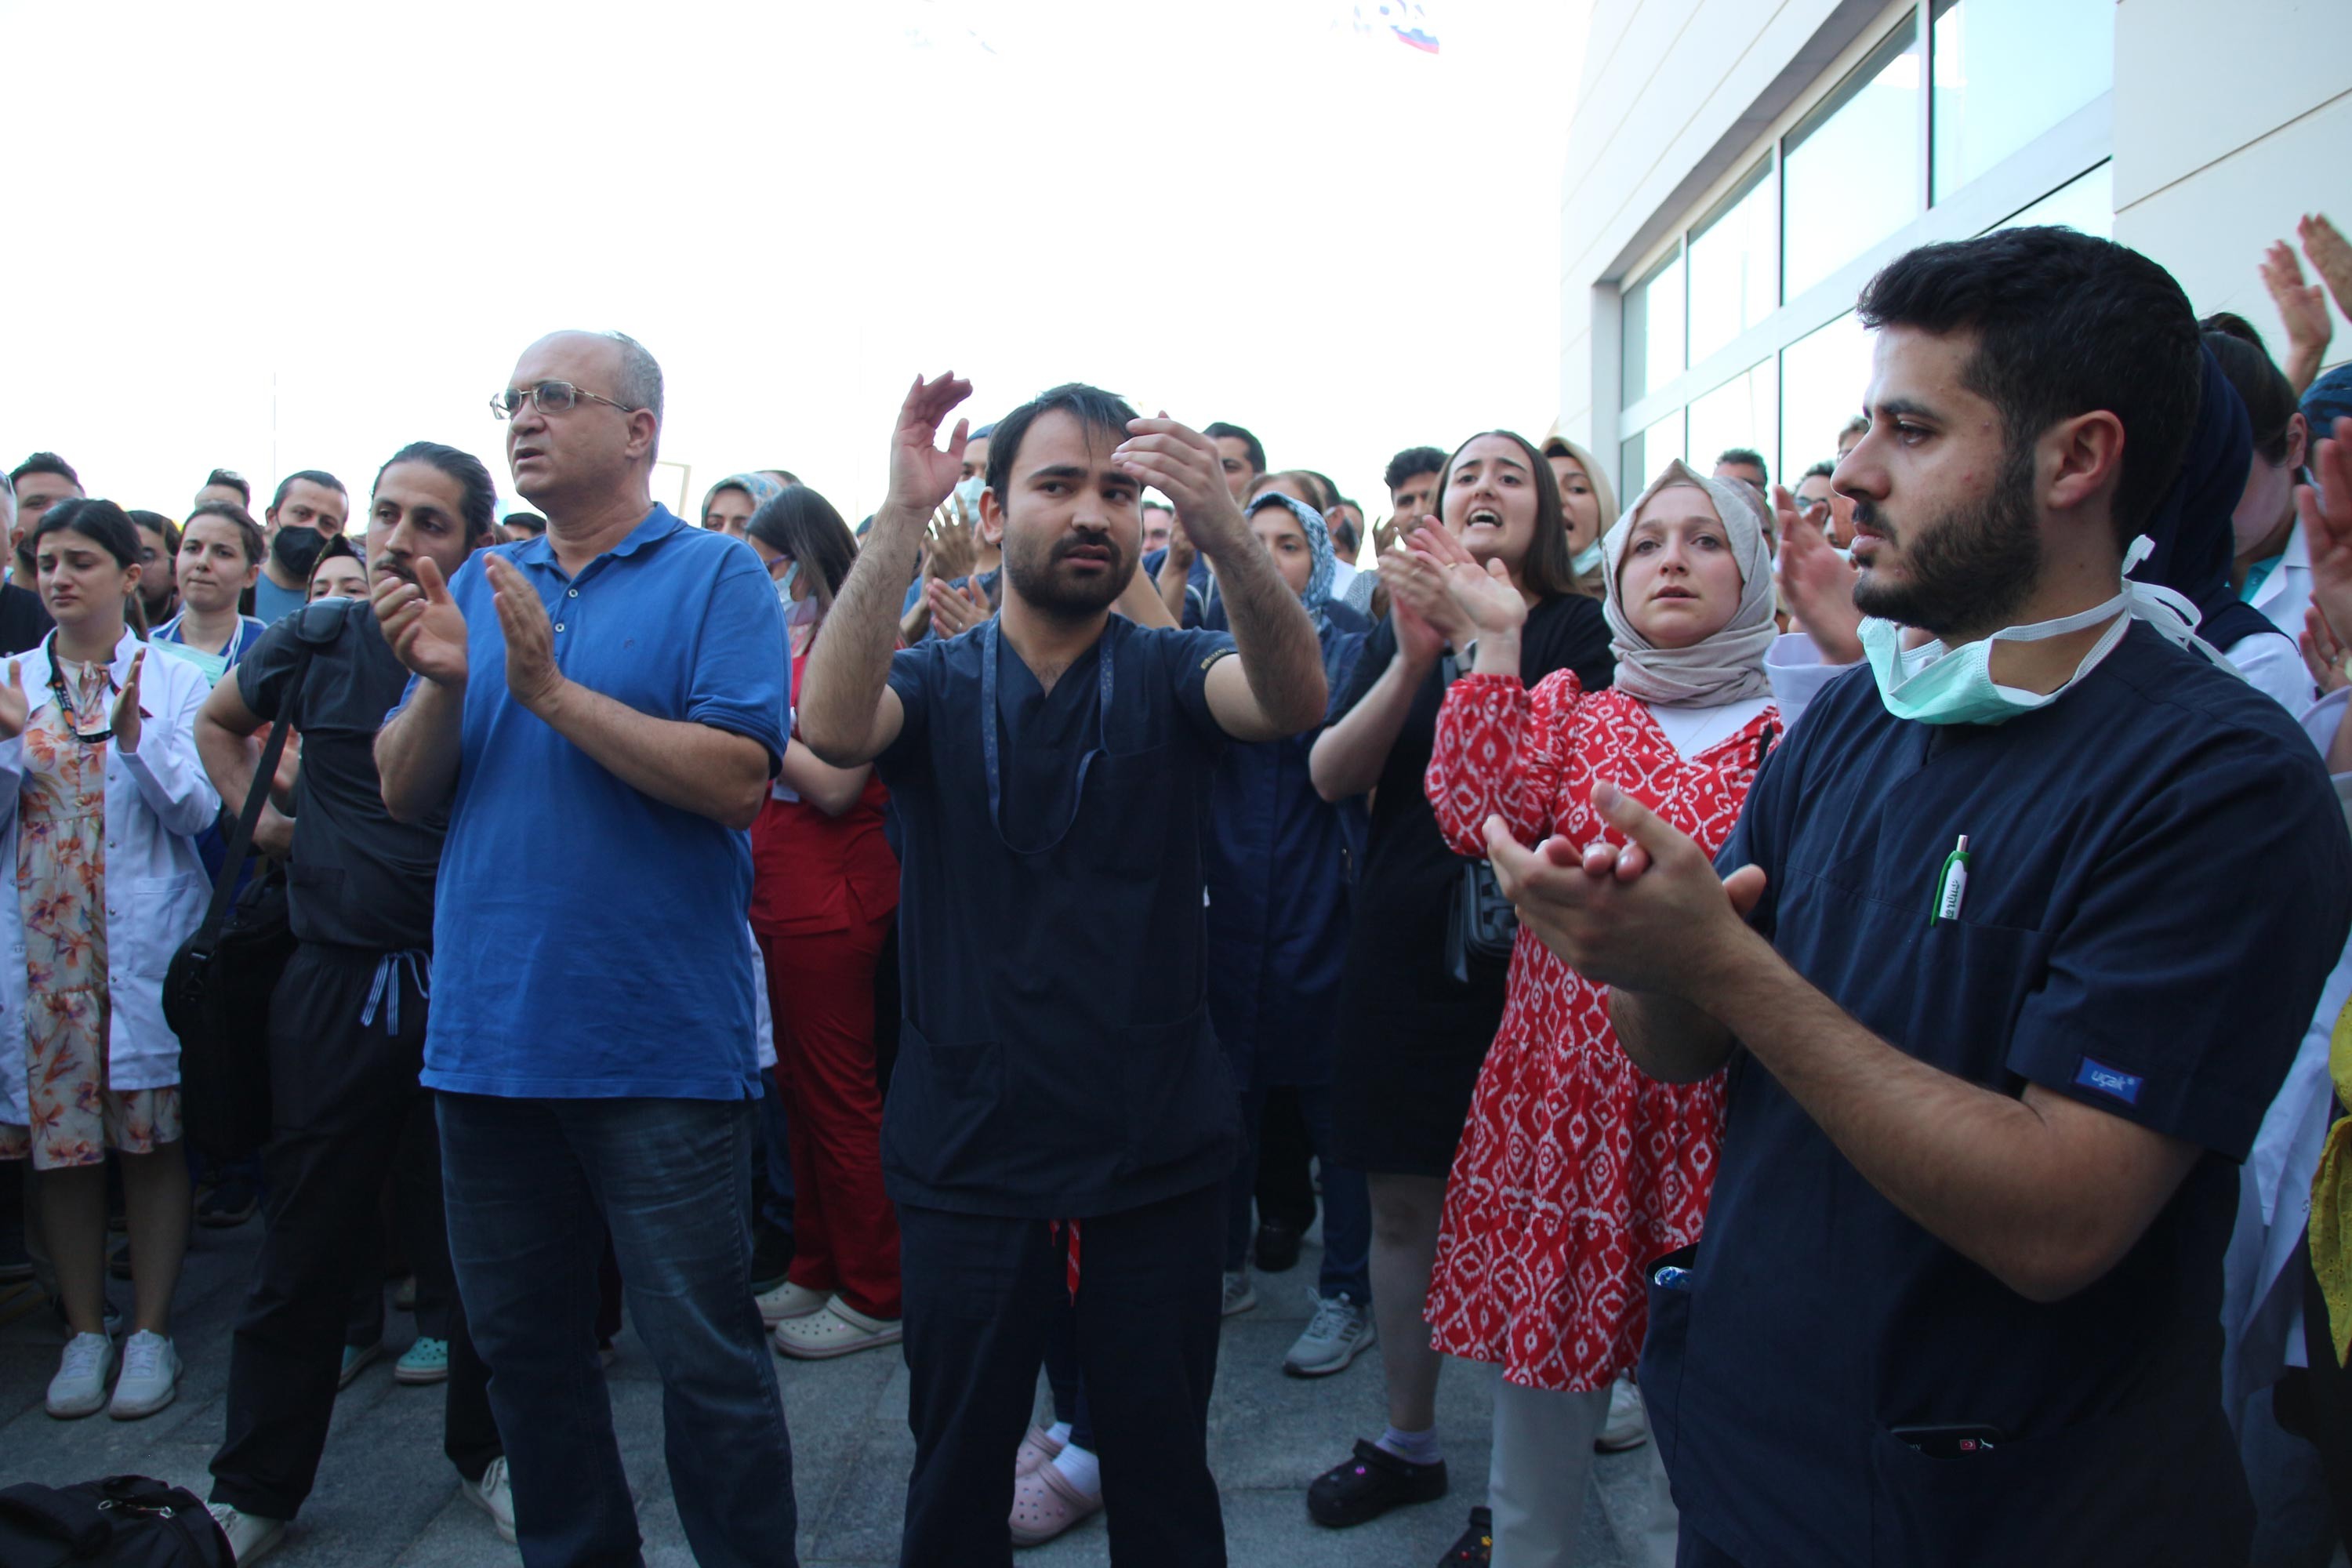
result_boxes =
[1428,670,1778,1392]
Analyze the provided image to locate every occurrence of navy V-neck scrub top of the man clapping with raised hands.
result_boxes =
[875,616,1240,1218]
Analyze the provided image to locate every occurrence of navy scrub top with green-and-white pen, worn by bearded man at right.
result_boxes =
[1642,626,2352,1568]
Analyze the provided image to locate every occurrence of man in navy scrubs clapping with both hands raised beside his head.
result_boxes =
[800,376,1327,1568]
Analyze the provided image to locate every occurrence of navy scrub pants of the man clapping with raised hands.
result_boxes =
[898,1182,1225,1568]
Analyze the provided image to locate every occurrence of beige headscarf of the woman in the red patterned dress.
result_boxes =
[1602,459,1778,708]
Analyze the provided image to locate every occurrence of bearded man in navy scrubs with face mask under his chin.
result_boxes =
[1489,228,2352,1568]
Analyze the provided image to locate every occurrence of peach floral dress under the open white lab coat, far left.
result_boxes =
[0,659,179,1171]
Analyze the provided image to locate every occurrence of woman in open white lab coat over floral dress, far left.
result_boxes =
[0,501,221,1417]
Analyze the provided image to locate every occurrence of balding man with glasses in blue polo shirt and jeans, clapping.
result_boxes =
[374,332,795,1566]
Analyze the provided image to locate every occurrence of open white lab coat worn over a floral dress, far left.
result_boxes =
[0,633,221,1126]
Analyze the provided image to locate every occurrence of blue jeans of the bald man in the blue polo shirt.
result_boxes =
[440,1093,797,1568]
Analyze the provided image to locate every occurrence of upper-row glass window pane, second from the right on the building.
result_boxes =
[1780,22,1919,299]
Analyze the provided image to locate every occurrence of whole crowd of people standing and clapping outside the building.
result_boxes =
[13,219,2352,1568]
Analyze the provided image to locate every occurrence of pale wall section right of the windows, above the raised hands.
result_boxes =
[2114,0,2352,365]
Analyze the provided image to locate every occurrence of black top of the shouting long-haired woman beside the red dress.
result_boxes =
[1331,595,1616,1051]
